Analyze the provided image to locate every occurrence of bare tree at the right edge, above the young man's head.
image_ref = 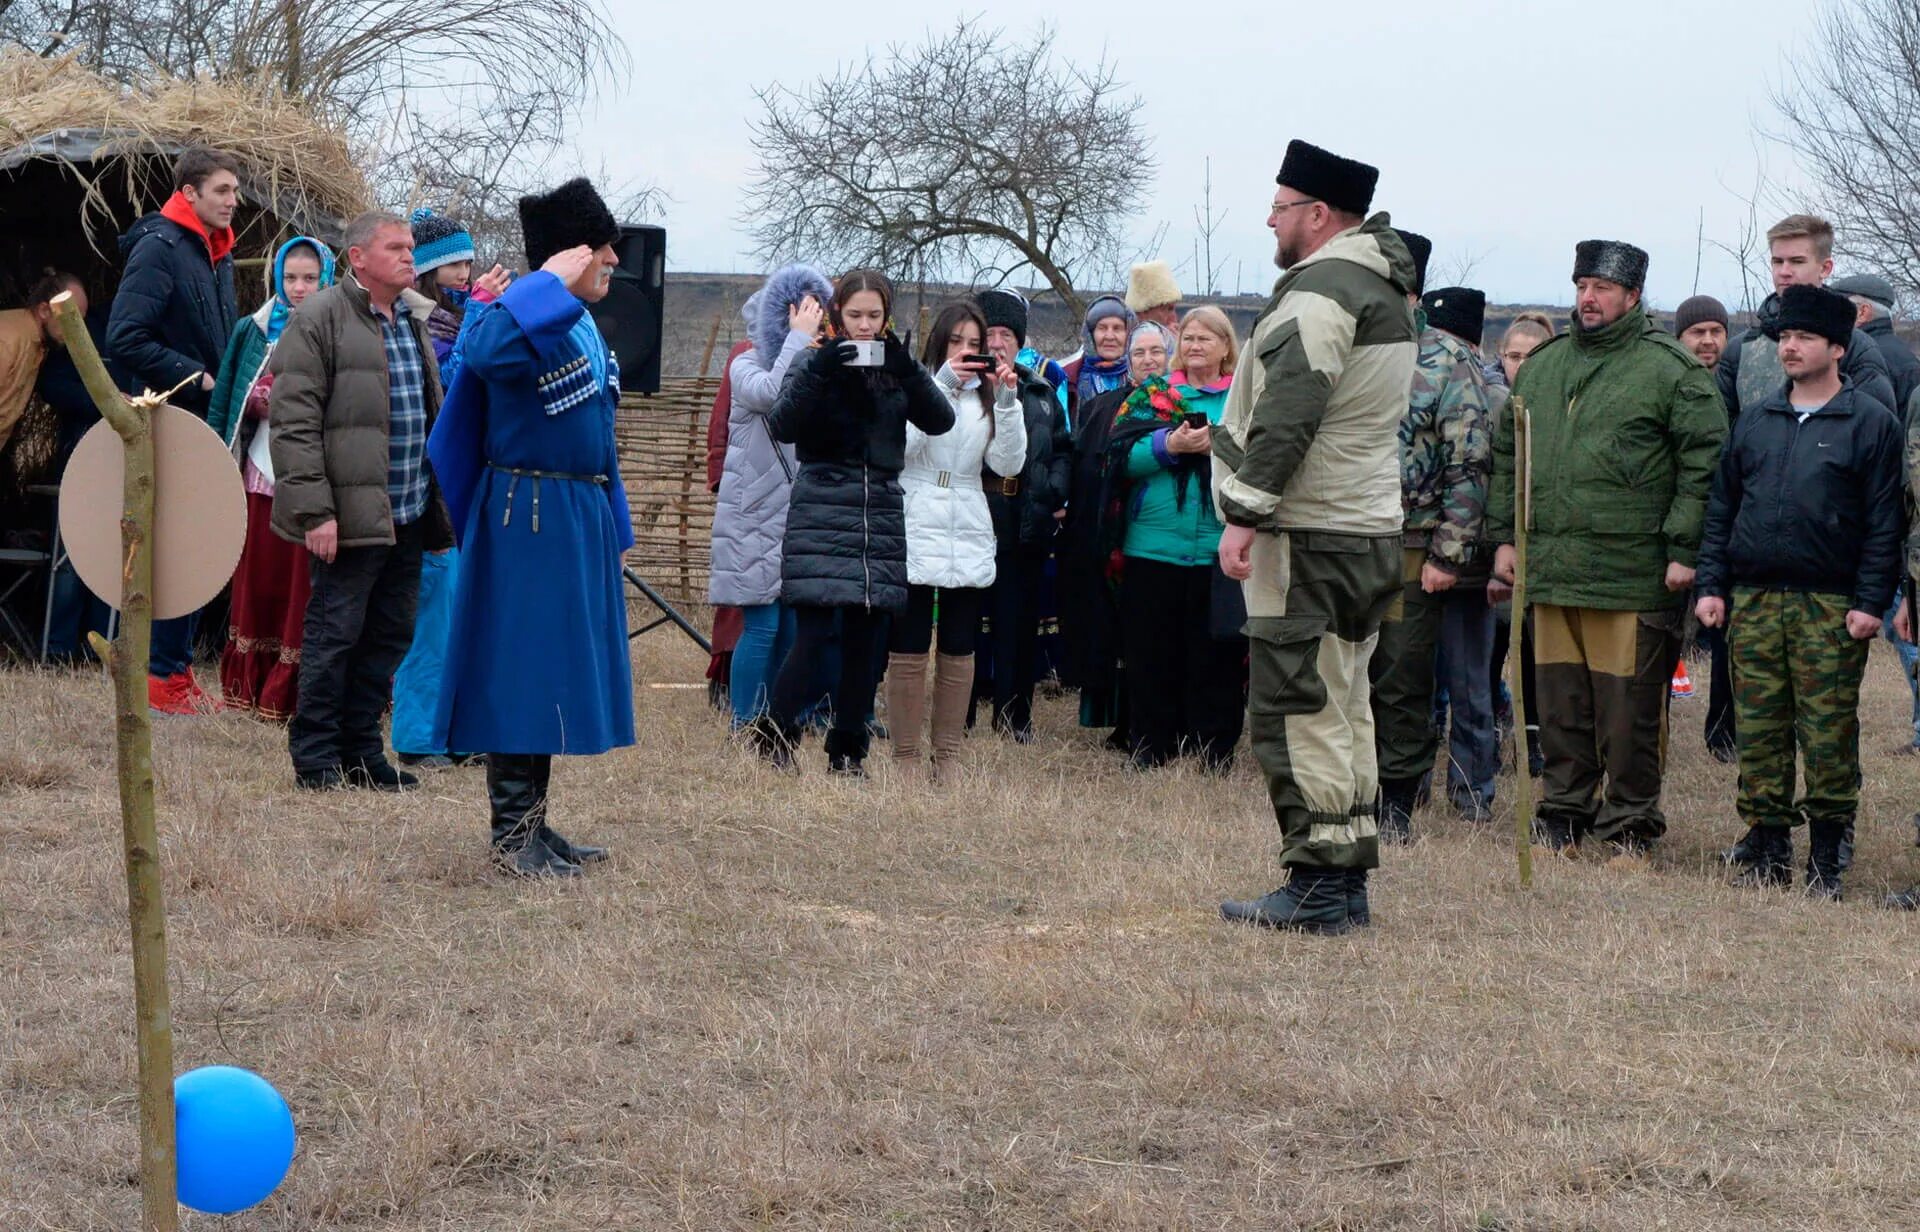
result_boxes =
[1766,0,1920,294]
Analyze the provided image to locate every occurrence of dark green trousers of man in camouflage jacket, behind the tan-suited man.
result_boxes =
[1367,547,1446,783]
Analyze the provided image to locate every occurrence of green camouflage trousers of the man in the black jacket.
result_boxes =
[1726,587,1868,825]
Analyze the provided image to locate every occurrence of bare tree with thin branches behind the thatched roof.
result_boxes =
[0,0,630,253]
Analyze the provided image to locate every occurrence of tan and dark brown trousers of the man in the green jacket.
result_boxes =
[1532,603,1682,841]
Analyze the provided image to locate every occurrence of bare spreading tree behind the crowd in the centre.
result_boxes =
[747,19,1154,313]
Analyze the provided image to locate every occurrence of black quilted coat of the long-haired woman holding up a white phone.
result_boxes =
[768,344,954,612]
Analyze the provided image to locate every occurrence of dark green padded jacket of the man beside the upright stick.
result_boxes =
[1486,307,1726,612]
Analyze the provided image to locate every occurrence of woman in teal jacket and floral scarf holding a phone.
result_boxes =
[1108,307,1246,771]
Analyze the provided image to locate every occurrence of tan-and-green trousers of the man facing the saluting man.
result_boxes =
[1240,532,1400,869]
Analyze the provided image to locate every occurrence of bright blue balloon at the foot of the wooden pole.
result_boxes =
[173,1065,294,1215]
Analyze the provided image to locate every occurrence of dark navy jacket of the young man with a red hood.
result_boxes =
[108,213,240,416]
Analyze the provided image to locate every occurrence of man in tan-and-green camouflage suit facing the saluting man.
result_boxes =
[1213,140,1419,935]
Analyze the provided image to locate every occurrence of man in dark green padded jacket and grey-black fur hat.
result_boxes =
[1486,240,1726,856]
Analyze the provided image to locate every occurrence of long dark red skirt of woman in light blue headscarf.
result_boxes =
[221,491,313,722]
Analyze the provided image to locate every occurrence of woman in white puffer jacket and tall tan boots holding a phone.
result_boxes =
[887,303,1054,773]
